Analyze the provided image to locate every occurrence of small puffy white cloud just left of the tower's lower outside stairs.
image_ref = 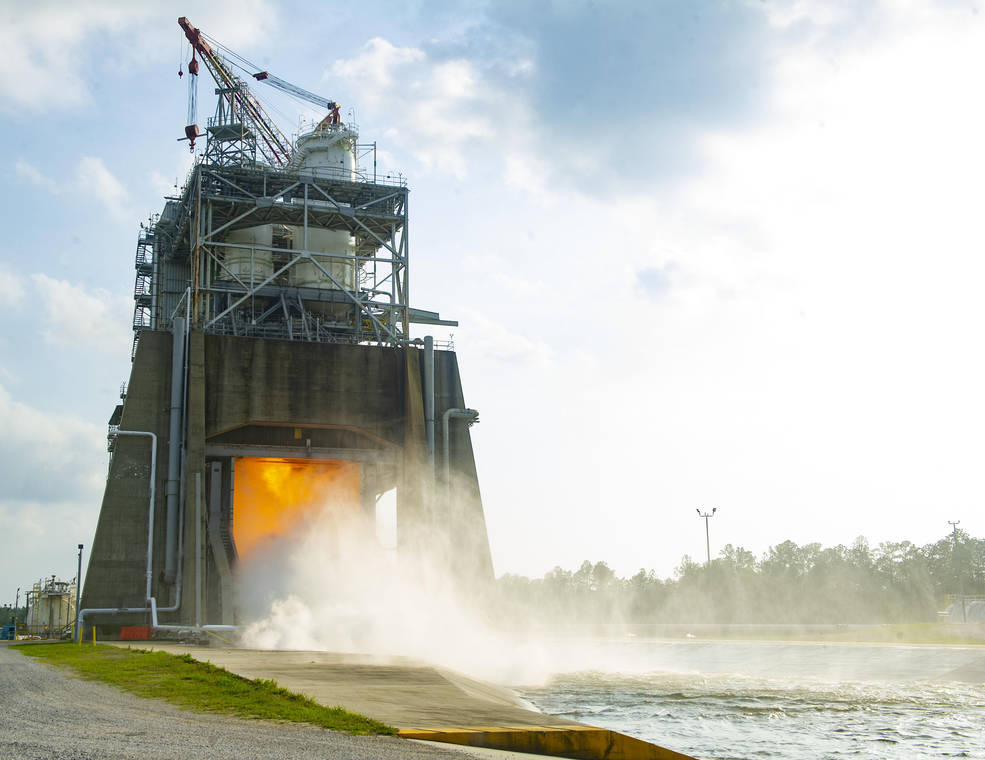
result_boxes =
[31,274,132,354]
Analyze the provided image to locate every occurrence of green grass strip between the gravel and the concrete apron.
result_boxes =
[17,643,396,734]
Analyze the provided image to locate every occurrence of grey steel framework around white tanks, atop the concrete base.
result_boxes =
[134,162,434,350]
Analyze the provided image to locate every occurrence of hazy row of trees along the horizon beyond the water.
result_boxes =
[497,531,985,624]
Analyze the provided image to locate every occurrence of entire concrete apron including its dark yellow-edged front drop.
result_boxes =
[111,642,693,760]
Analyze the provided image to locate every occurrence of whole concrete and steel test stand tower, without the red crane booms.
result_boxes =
[81,58,492,636]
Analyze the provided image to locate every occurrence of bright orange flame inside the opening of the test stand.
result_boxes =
[233,457,359,557]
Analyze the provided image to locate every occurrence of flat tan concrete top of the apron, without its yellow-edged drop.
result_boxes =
[124,642,582,729]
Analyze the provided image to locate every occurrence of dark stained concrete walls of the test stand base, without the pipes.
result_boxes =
[83,330,492,624]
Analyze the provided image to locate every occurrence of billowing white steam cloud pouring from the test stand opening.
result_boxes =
[237,469,547,682]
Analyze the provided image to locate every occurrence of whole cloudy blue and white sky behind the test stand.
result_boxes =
[0,0,985,602]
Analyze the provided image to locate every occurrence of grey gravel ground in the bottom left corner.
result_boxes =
[0,646,463,760]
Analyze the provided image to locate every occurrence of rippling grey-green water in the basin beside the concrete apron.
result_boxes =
[519,641,985,760]
